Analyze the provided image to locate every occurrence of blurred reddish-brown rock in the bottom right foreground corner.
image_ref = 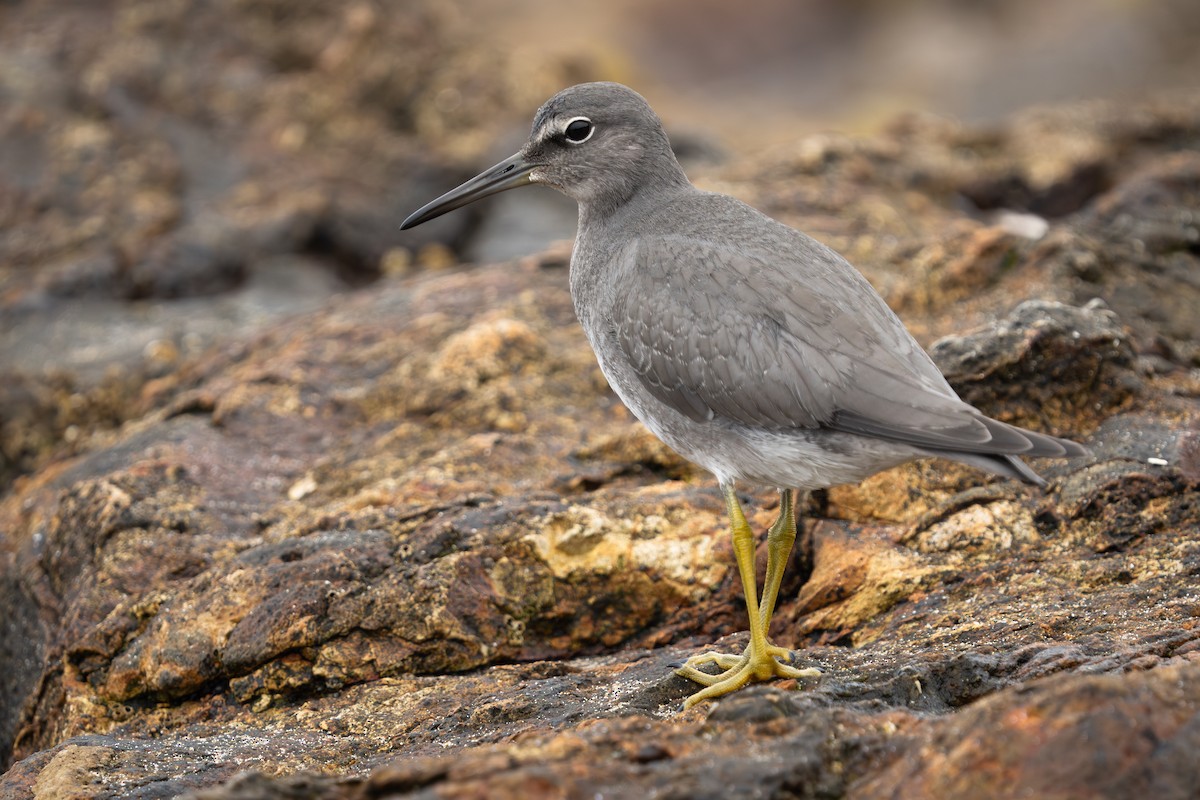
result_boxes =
[851,660,1200,798]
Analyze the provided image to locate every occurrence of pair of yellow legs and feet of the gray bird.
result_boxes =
[677,485,821,709]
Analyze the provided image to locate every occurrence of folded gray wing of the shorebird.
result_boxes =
[613,230,1055,453]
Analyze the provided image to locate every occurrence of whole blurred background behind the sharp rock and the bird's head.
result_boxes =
[0,0,1200,482]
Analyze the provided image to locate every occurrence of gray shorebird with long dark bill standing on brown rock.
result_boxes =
[401,83,1087,708]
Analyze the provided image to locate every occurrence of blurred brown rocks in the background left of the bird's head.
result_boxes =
[0,0,592,491]
